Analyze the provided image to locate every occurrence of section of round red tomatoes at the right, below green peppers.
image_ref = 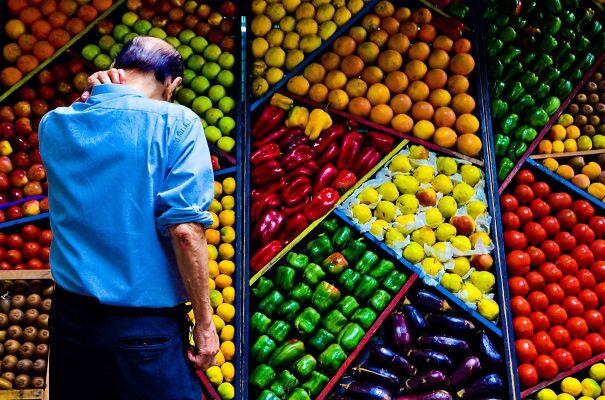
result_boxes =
[500,170,605,388]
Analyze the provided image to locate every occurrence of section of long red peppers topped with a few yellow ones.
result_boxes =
[250,94,395,272]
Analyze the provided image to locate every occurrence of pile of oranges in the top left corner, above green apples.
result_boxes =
[0,0,113,86]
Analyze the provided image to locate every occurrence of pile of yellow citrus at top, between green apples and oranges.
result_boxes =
[250,0,364,97]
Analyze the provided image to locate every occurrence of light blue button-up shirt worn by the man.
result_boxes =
[39,85,214,307]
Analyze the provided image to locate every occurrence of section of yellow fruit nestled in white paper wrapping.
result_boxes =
[341,146,499,321]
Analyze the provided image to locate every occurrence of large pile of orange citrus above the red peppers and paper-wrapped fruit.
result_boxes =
[287,0,482,157]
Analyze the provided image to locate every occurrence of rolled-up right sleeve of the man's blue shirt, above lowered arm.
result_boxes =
[156,118,214,236]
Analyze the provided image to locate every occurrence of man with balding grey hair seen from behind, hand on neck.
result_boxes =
[39,37,219,400]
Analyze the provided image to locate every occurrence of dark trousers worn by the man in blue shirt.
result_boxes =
[49,288,202,400]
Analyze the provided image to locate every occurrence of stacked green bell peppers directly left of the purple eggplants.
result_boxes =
[249,219,407,400]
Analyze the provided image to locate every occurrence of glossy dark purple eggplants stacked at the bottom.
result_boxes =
[330,287,504,400]
